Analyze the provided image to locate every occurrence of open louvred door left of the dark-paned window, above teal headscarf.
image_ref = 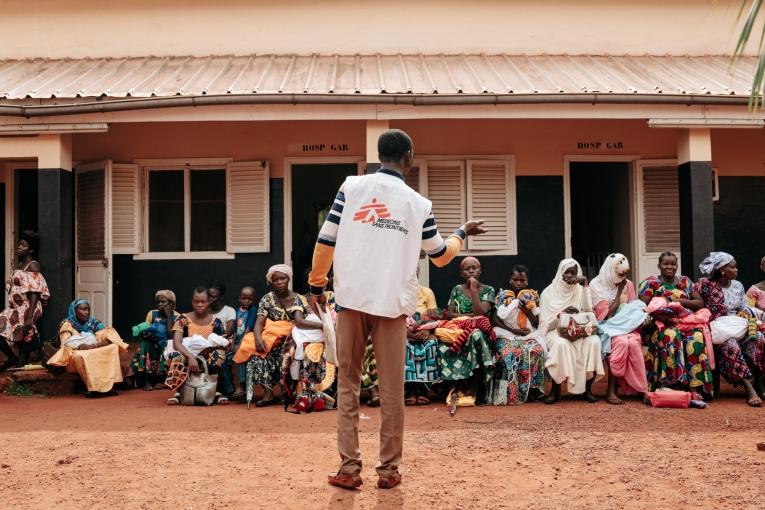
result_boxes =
[75,161,112,324]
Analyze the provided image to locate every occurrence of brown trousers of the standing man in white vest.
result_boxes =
[337,309,406,476]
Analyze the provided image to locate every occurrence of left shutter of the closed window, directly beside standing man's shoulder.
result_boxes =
[426,160,465,236]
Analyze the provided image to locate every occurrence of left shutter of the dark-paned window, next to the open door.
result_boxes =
[111,163,142,255]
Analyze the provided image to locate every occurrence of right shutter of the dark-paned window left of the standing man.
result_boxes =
[226,161,271,253]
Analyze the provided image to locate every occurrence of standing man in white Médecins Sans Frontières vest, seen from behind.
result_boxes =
[308,129,485,489]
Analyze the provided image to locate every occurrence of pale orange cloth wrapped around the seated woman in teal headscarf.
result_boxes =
[48,321,127,393]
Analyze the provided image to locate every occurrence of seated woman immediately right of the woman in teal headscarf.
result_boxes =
[127,290,180,391]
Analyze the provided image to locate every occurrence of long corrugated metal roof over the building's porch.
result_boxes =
[0,54,755,104]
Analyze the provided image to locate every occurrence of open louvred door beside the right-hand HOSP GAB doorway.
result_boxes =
[633,159,682,283]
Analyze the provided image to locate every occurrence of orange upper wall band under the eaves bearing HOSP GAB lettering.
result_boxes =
[73,119,765,177]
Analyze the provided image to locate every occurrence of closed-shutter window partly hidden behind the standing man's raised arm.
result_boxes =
[407,157,517,255]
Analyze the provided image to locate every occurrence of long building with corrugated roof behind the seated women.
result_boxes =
[0,0,765,342]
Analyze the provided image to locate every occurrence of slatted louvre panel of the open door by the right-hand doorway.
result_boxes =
[643,166,680,253]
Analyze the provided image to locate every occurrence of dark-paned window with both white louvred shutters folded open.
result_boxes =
[123,159,270,259]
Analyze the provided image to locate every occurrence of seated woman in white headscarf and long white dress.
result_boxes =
[539,259,605,404]
